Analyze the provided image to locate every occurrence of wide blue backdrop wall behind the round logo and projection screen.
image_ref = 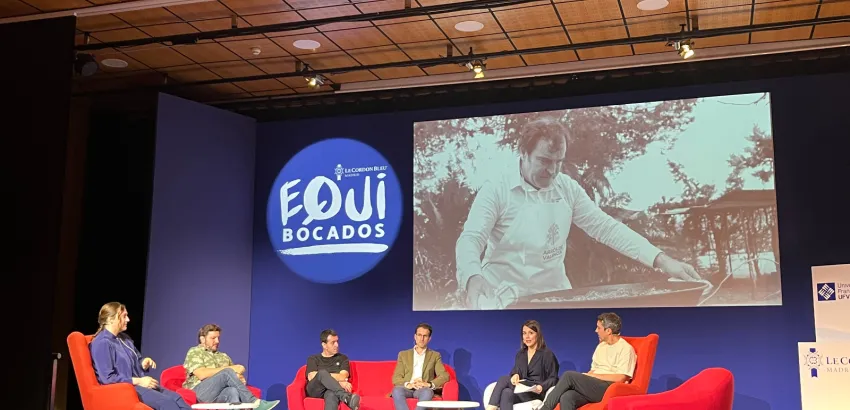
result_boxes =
[248,74,850,410]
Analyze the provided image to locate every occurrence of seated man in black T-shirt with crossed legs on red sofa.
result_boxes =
[306,329,360,410]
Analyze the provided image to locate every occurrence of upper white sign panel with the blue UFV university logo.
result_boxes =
[812,265,850,342]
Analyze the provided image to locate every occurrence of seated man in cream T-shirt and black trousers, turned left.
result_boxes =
[540,313,637,410]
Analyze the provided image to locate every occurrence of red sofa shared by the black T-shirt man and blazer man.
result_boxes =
[286,360,458,410]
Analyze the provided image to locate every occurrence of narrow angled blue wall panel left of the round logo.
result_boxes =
[143,94,256,377]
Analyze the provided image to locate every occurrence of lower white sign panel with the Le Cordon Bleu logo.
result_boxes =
[797,342,850,410]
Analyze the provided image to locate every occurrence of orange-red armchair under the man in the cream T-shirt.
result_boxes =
[555,333,658,410]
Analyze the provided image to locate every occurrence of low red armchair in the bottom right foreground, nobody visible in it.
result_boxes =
[608,367,735,410]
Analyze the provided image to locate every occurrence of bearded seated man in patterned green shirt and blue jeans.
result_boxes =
[183,324,280,410]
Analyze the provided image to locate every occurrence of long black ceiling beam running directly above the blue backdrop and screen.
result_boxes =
[215,49,850,121]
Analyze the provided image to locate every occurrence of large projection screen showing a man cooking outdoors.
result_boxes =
[413,93,782,311]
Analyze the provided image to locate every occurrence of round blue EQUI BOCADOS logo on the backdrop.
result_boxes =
[266,138,402,283]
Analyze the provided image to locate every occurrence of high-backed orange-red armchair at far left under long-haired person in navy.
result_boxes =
[67,332,151,410]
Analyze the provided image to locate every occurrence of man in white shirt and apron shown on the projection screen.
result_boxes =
[455,118,701,309]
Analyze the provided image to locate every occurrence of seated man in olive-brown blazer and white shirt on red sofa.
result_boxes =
[392,323,449,410]
